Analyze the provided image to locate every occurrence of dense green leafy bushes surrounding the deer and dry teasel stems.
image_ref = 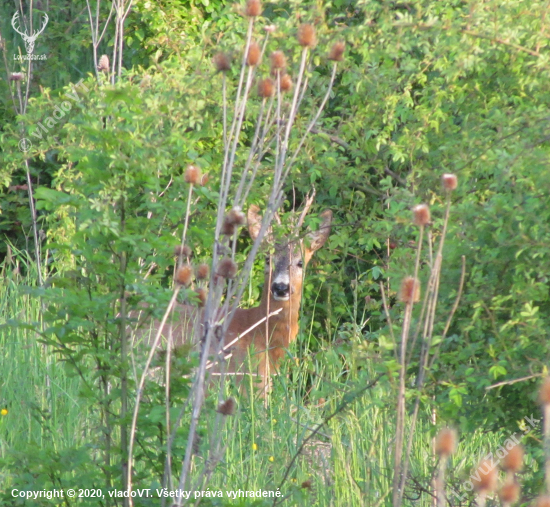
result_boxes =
[0,0,550,505]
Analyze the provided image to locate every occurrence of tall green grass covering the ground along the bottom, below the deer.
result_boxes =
[0,253,531,506]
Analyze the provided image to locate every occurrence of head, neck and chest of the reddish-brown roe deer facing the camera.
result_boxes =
[209,206,332,391]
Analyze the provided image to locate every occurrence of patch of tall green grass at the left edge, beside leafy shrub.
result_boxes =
[0,248,86,487]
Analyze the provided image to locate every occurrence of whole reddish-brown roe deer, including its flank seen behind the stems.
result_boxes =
[136,203,332,393]
